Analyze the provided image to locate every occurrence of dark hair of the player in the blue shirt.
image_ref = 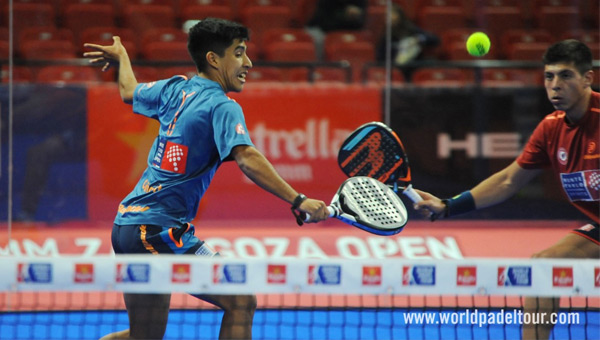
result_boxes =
[188,18,250,72]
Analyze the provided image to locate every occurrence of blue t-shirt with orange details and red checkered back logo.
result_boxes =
[115,76,253,226]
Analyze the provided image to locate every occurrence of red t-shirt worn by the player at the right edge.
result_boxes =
[517,92,600,223]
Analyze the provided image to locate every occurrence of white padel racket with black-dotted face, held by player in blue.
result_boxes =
[299,176,408,236]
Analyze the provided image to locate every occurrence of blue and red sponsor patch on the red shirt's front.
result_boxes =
[560,170,600,201]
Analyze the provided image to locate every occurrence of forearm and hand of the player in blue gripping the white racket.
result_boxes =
[231,145,329,223]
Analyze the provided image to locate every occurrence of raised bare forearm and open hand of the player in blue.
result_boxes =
[83,36,138,104]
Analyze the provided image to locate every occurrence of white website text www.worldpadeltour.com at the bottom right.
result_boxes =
[403,309,580,327]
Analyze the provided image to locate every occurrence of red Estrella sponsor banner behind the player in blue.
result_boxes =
[88,84,381,220]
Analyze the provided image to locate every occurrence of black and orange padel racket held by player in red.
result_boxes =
[338,122,422,202]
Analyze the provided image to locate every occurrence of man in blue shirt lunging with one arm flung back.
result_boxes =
[84,18,328,339]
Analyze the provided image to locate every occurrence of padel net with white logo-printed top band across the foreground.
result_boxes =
[0,255,600,340]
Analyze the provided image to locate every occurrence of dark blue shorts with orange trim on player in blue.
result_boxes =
[111,223,217,256]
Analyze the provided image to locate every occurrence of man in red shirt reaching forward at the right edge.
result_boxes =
[415,40,600,339]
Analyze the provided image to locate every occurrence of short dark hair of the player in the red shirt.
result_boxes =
[542,39,593,74]
